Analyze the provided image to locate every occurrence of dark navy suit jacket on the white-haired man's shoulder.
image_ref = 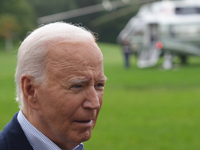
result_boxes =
[0,113,33,150]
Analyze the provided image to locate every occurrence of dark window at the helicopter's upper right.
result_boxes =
[175,7,200,15]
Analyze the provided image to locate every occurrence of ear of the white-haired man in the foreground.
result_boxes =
[21,74,38,109]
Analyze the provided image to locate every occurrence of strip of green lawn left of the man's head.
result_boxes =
[0,50,18,130]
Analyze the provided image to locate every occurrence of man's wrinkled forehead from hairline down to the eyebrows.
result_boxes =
[44,41,104,79]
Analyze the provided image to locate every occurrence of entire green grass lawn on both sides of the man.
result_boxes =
[0,43,200,150]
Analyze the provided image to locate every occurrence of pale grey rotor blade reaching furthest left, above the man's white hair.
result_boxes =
[38,1,128,24]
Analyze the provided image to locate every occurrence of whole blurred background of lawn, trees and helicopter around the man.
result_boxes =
[0,0,200,150]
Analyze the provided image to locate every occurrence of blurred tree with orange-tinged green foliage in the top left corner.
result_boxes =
[0,0,36,48]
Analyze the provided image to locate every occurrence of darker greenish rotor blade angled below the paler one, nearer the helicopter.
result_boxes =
[90,0,159,26]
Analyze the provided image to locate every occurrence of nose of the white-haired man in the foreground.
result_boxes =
[83,87,100,109]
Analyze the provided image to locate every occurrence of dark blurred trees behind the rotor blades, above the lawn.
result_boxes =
[0,0,140,43]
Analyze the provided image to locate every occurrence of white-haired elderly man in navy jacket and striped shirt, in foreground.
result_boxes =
[0,22,106,150]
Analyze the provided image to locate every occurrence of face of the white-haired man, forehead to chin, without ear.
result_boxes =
[35,39,105,148]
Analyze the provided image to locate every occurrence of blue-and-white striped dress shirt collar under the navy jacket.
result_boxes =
[17,110,84,150]
